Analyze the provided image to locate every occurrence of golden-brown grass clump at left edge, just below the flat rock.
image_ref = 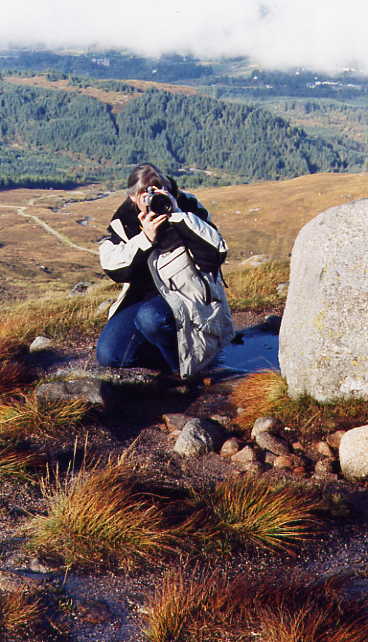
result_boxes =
[0,393,90,440]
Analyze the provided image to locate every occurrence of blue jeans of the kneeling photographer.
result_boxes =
[96,295,179,371]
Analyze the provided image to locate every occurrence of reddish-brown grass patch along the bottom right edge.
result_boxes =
[145,569,368,642]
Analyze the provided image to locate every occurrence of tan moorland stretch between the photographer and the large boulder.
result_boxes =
[201,172,368,262]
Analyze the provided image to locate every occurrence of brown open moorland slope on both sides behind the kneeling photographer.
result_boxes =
[0,174,368,300]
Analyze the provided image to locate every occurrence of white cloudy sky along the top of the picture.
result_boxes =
[0,0,368,71]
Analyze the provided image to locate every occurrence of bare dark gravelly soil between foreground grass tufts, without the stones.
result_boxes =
[0,311,368,642]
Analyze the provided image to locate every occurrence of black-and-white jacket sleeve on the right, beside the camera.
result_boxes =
[170,195,228,273]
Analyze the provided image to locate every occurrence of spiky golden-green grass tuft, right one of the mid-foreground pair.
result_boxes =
[198,477,318,552]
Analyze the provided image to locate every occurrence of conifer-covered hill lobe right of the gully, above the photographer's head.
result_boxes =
[117,91,356,181]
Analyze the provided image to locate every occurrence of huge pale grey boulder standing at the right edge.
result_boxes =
[279,199,368,401]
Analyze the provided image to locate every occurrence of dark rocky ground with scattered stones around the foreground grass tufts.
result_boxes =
[0,310,368,642]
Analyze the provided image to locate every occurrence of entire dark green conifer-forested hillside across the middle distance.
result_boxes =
[0,82,364,187]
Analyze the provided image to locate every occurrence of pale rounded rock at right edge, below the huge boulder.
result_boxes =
[339,426,368,481]
